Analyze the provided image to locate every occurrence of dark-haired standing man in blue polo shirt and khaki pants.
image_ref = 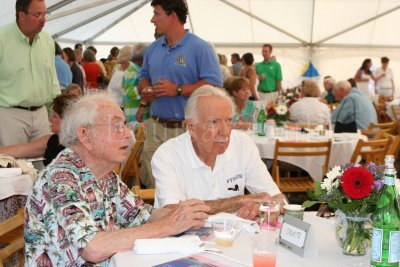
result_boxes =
[139,0,222,188]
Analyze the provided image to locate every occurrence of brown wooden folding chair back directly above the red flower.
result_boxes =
[350,138,389,165]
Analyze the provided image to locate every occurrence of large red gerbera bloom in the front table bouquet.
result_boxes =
[342,167,374,199]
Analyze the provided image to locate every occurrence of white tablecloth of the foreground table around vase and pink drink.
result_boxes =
[109,212,369,267]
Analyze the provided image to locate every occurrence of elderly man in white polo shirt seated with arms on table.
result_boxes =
[152,85,284,219]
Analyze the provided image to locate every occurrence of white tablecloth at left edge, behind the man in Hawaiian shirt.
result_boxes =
[0,174,35,200]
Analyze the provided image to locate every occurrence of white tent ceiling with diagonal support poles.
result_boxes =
[0,0,400,48]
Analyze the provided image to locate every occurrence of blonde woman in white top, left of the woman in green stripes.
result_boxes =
[108,46,132,107]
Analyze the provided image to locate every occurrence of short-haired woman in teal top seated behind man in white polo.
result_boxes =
[226,77,256,130]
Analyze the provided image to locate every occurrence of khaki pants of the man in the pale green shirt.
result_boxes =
[0,106,50,146]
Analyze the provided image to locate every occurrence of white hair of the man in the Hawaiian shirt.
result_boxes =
[59,92,114,147]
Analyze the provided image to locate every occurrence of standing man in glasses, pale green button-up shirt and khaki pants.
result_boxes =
[0,0,61,146]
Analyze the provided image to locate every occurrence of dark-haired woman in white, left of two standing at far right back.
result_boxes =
[354,58,375,98]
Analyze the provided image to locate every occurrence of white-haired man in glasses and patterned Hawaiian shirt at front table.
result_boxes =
[24,95,209,266]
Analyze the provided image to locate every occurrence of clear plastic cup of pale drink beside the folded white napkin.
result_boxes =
[211,220,240,247]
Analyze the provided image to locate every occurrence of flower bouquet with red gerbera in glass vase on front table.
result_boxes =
[303,162,385,255]
